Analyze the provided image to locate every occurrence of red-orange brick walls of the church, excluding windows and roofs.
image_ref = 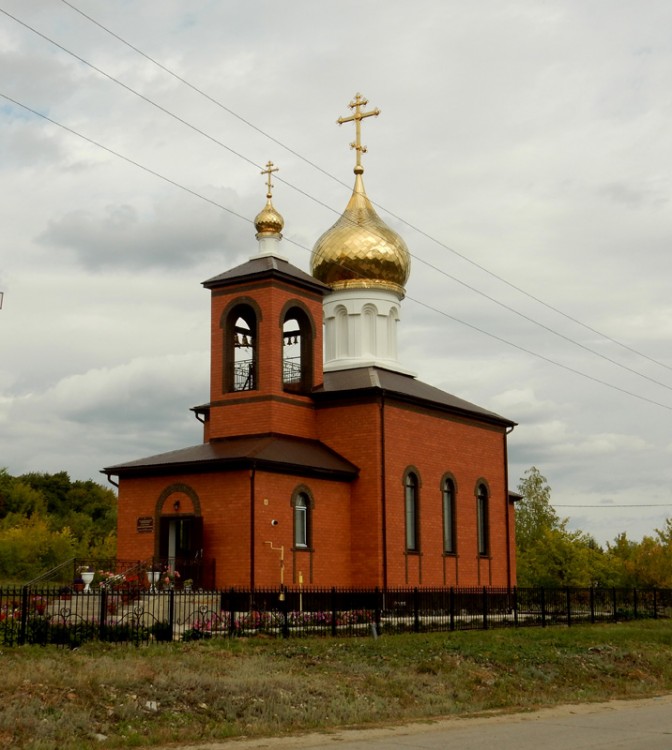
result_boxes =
[118,268,515,587]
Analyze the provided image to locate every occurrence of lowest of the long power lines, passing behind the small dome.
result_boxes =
[0,92,672,418]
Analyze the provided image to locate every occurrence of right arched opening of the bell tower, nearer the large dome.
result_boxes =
[282,304,315,393]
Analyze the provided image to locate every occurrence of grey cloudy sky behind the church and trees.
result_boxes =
[0,0,672,543]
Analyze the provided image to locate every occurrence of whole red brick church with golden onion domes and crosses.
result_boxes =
[103,94,517,589]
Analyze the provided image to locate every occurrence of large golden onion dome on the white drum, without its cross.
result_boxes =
[311,175,411,295]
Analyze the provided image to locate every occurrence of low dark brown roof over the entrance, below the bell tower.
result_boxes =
[103,435,359,481]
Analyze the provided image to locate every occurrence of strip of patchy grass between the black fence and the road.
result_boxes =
[0,621,672,750]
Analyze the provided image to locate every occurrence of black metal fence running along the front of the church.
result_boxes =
[0,585,672,648]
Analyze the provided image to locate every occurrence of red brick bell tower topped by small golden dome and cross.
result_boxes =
[197,161,328,442]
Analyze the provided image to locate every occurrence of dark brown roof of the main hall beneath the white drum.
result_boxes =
[313,367,516,427]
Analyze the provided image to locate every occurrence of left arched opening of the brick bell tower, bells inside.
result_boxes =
[222,302,259,392]
